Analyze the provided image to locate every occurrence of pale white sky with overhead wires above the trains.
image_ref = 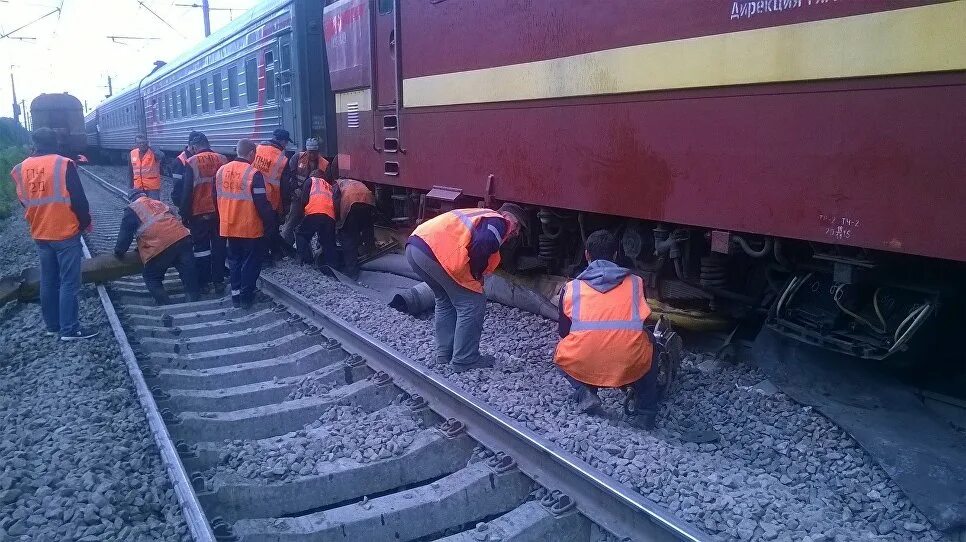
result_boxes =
[0,0,258,123]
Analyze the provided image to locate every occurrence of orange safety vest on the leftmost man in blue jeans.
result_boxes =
[10,154,80,241]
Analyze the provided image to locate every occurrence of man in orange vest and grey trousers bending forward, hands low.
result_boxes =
[406,204,525,372]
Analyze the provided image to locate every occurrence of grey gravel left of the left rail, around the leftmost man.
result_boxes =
[0,186,190,541]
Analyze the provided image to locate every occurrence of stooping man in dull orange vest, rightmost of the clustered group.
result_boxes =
[335,179,376,278]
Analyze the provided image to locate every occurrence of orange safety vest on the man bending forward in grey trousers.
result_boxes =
[413,209,506,293]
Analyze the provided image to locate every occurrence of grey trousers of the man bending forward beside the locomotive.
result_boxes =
[406,245,486,364]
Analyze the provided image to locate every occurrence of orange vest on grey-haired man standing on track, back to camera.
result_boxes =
[215,161,265,239]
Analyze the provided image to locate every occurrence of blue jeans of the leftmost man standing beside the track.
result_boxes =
[36,234,84,335]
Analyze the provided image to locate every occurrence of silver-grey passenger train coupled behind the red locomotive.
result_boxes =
[88,0,335,164]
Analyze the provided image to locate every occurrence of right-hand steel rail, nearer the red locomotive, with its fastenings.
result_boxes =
[259,277,710,542]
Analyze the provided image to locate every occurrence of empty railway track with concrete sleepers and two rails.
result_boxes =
[73,171,706,541]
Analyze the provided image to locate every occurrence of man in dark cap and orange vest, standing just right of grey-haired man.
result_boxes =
[252,128,292,265]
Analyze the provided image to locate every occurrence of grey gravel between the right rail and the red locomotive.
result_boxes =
[263,261,941,542]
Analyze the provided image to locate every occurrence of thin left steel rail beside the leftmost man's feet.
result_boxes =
[81,232,215,542]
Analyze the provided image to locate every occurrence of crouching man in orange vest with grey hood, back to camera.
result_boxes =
[554,230,658,429]
